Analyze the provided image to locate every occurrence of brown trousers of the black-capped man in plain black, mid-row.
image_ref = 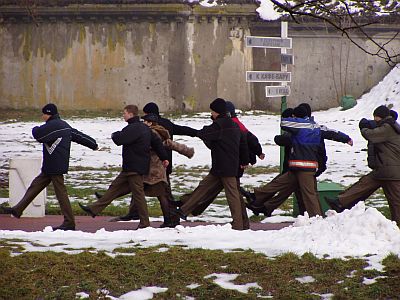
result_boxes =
[181,173,248,230]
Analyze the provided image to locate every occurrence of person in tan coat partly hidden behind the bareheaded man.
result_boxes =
[101,113,194,228]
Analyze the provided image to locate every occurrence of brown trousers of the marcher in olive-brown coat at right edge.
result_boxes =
[339,173,400,226]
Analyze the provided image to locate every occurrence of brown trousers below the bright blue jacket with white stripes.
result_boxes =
[254,170,323,217]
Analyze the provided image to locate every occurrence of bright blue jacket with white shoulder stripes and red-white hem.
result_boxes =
[281,117,321,172]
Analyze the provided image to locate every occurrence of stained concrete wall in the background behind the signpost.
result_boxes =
[0,4,400,111]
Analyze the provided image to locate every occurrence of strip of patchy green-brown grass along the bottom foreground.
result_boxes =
[0,247,400,299]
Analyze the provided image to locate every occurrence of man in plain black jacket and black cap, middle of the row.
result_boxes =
[175,98,249,230]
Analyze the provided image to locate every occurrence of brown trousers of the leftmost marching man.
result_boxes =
[13,173,75,226]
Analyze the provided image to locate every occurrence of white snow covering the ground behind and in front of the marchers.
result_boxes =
[0,64,400,269]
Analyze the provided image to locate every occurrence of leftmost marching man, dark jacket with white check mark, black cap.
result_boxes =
[2,103,98,230]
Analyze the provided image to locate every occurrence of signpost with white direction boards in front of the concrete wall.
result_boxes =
[246,22,294,171]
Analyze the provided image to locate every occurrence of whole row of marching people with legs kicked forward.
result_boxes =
[1,98,400,230]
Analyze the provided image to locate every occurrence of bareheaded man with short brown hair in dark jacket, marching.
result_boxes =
[79,105,169,228]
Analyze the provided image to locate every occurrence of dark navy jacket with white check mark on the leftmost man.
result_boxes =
[32,114,97,175]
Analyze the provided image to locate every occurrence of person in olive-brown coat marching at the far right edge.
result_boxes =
[325,105,400,226]
